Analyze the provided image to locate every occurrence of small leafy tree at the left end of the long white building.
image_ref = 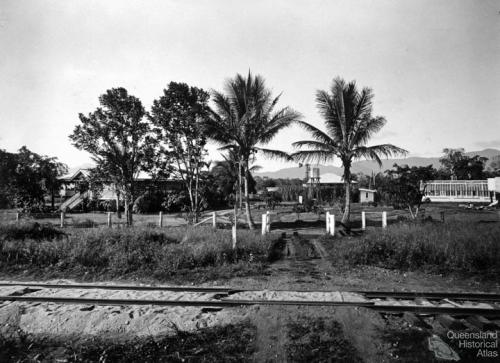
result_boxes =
[382,164,436,219]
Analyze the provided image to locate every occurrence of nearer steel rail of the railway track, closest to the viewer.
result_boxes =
[0,296,500,317]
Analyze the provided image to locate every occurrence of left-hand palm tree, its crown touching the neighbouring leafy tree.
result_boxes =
[207,72,301,229]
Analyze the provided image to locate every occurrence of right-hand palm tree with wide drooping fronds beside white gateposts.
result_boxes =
[292,77,407,224]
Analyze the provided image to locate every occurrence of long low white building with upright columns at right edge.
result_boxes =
[420,177,500,203]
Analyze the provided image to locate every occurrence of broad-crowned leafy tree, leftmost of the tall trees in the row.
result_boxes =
[69,88,153,225]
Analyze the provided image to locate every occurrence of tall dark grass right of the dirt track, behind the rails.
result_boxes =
[323,221,500,277]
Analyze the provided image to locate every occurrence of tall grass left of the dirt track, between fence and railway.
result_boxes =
[0,225,279,279]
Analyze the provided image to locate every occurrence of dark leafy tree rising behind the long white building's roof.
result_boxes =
[439,148,488,180]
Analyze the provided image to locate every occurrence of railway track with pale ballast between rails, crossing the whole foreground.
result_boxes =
[0,282,500,318]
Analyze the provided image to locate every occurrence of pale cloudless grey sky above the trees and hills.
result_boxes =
[0,0,500,171]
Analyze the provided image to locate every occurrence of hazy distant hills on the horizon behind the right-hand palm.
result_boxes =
[255,149,500,179]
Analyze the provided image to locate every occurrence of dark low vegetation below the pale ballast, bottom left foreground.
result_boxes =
[0,321,256,362]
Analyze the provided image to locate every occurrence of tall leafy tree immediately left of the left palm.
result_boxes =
[149,82,209,222]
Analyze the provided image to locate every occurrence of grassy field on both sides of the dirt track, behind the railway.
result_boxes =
[0,204,500,281]
